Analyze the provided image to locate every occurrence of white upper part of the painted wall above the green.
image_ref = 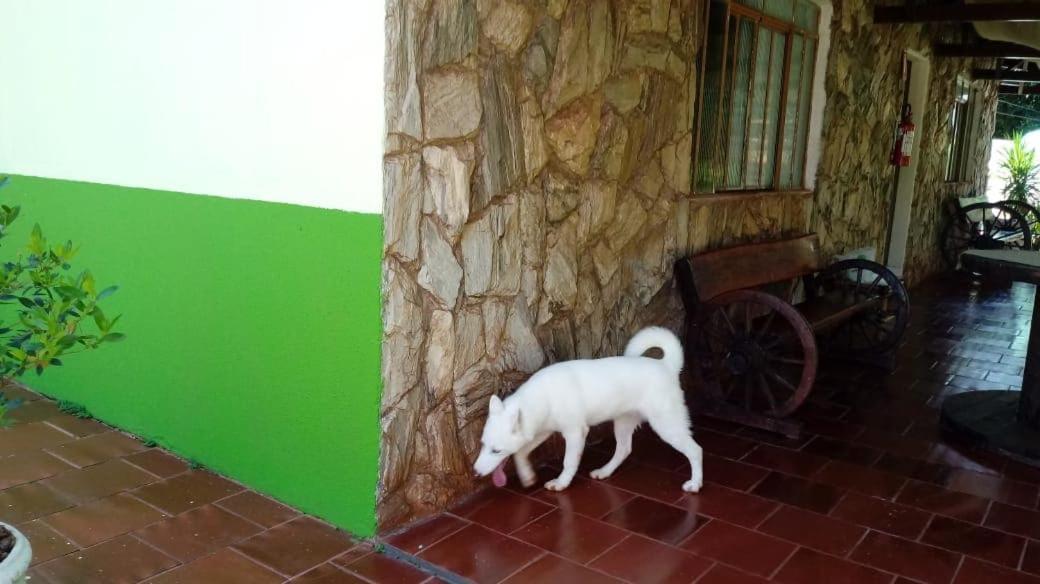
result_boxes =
[0,0,385,213]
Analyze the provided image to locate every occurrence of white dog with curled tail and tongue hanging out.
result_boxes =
[473,327,703,493]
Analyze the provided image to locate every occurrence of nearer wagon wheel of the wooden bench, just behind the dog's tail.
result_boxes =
[698,290,817,418]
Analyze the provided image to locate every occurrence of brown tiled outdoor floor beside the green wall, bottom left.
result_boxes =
[0,387,435,584]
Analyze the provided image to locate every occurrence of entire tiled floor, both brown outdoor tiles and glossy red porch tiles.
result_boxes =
[6,274,1040,584]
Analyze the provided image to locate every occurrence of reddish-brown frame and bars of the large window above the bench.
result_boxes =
[691,0,826,196]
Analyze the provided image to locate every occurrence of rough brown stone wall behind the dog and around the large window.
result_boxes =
[379,0,994,530]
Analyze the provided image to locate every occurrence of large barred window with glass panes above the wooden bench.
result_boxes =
[694,0,820,193]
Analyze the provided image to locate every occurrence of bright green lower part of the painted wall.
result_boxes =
[0,177,383,535]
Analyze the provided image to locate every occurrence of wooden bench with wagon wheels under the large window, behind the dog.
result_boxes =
[676,235,910,436]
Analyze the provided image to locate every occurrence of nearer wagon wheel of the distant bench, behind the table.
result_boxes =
[942,203,1033,269]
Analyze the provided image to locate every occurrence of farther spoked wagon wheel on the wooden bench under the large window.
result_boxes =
[811,260,910,354]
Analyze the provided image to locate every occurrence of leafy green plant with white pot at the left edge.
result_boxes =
[0,178,123,573]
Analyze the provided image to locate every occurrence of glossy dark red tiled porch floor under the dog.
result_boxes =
[387,282,1040,584]
